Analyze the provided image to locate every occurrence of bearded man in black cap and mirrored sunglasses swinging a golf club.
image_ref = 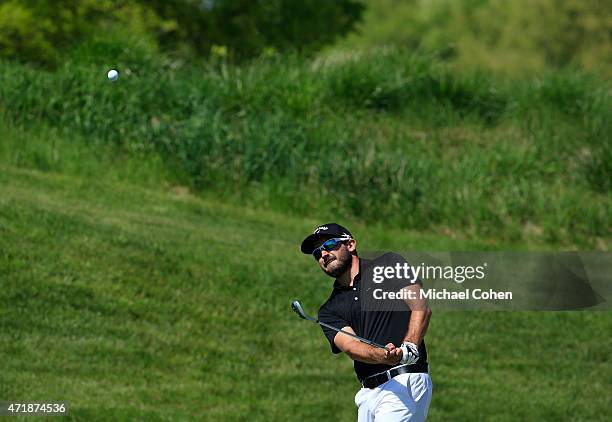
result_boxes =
[301,223,432,422]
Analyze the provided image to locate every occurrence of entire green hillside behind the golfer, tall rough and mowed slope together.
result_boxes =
[0,50,612,421]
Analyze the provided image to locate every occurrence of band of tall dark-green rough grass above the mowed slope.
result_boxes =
[0,50,612,247]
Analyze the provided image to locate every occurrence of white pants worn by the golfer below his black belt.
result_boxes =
[355,374,432,422]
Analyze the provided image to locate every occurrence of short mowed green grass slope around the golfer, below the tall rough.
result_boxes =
[0,165,612,421]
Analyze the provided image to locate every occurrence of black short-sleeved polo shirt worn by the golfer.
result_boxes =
[318,253,427,381]
